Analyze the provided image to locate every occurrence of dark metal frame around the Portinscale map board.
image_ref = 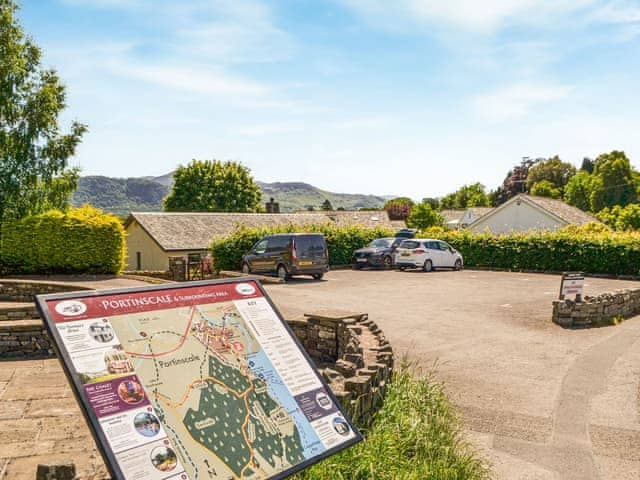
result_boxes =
[35,276,363,480]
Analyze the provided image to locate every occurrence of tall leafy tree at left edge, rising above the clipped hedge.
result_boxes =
[0,0,87,222]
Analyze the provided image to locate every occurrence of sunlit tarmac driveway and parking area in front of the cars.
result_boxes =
[267,270,640,480]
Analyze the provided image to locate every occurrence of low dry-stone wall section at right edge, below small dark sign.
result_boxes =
[552,288,640,328]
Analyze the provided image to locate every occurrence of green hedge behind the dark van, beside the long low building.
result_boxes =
[211,225,394,271]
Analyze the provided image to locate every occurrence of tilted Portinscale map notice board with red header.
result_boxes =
[36,278,361,480]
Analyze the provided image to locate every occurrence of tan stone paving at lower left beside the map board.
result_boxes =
[0,358,108,480]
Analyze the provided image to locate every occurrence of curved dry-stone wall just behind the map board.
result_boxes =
[287,311,393,426]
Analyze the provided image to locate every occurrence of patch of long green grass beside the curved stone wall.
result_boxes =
[293,365,490,480]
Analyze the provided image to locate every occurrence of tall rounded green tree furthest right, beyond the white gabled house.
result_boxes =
[591,150,638,211]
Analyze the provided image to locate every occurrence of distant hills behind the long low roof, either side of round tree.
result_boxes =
[72,173,386,216]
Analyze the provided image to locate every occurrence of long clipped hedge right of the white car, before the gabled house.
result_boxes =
[420,225,640,275]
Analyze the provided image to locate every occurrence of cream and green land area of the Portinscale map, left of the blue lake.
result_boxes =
[111,302,305,480]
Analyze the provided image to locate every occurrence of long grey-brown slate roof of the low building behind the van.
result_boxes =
[125,212,331,251]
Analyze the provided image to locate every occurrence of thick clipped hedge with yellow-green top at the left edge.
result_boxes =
[0,206,126,274]
